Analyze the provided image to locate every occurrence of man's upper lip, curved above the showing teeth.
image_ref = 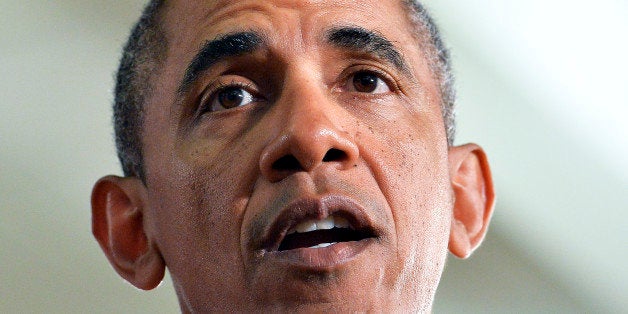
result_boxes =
[263,195,377,252]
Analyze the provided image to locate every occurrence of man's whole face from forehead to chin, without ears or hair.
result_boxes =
[143,0,452,312]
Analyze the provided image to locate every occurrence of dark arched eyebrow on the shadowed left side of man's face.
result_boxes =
[179,31,264,94]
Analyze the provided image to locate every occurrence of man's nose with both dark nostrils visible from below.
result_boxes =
[260,86,359,182]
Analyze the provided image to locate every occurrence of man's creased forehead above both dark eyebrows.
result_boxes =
[163,0,416,50]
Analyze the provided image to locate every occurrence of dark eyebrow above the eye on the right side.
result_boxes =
[327,26,409,72]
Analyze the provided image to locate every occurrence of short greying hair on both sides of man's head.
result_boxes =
[113,0,456,182]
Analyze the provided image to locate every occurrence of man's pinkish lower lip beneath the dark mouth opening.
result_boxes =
[265,238,374,271]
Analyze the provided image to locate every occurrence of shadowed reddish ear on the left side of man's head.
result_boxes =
[92,176,165,290]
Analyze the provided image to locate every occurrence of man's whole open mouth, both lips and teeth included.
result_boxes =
[252,195,385,273]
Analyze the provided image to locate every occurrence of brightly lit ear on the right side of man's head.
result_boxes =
[449,144,495,258]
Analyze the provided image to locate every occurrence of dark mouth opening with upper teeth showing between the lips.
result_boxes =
[278,215,373,252]
